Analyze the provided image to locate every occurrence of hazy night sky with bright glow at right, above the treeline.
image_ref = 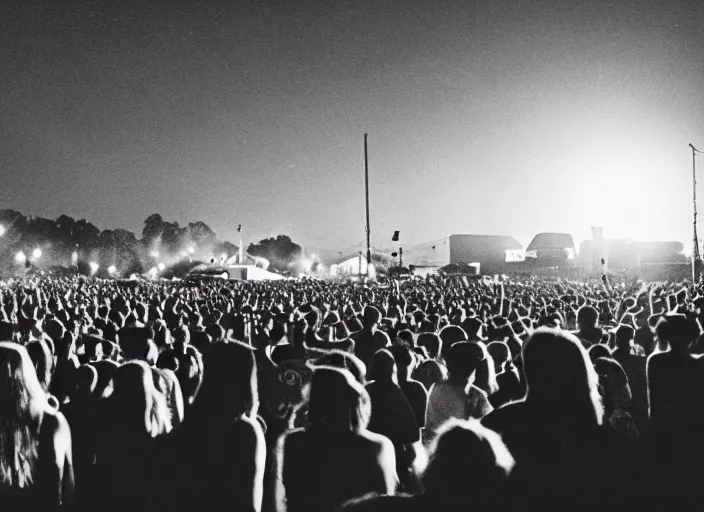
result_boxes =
[0,0,704,254]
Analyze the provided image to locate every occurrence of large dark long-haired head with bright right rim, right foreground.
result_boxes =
[523,328,603,428]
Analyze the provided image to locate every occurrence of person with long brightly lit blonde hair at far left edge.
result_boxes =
[0,342,74,510]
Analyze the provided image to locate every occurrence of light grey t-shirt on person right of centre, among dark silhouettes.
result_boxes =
[425,382,494,438]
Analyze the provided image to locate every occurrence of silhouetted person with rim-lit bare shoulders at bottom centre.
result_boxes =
[276,366,398,512]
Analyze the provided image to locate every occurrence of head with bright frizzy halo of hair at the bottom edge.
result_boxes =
[423,418,515,510]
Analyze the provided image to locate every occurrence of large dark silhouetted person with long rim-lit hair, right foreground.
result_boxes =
[482,328,624,510]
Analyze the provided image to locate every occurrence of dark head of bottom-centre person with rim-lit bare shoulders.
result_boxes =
[308,366,371,432]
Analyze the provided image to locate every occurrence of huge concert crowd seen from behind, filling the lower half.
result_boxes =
[0,276,704,512]
